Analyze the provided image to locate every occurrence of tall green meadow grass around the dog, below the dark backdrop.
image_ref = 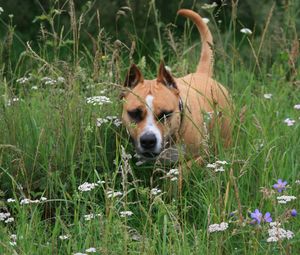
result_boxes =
[0,1,300,254]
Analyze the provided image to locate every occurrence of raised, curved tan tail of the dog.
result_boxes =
[177,9,213,77]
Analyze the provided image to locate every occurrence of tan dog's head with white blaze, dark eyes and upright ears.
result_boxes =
[122,63,181,158]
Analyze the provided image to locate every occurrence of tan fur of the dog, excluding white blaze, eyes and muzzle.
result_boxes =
[122,9,231,157]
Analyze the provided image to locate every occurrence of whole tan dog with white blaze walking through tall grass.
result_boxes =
[121,9,232,169]
